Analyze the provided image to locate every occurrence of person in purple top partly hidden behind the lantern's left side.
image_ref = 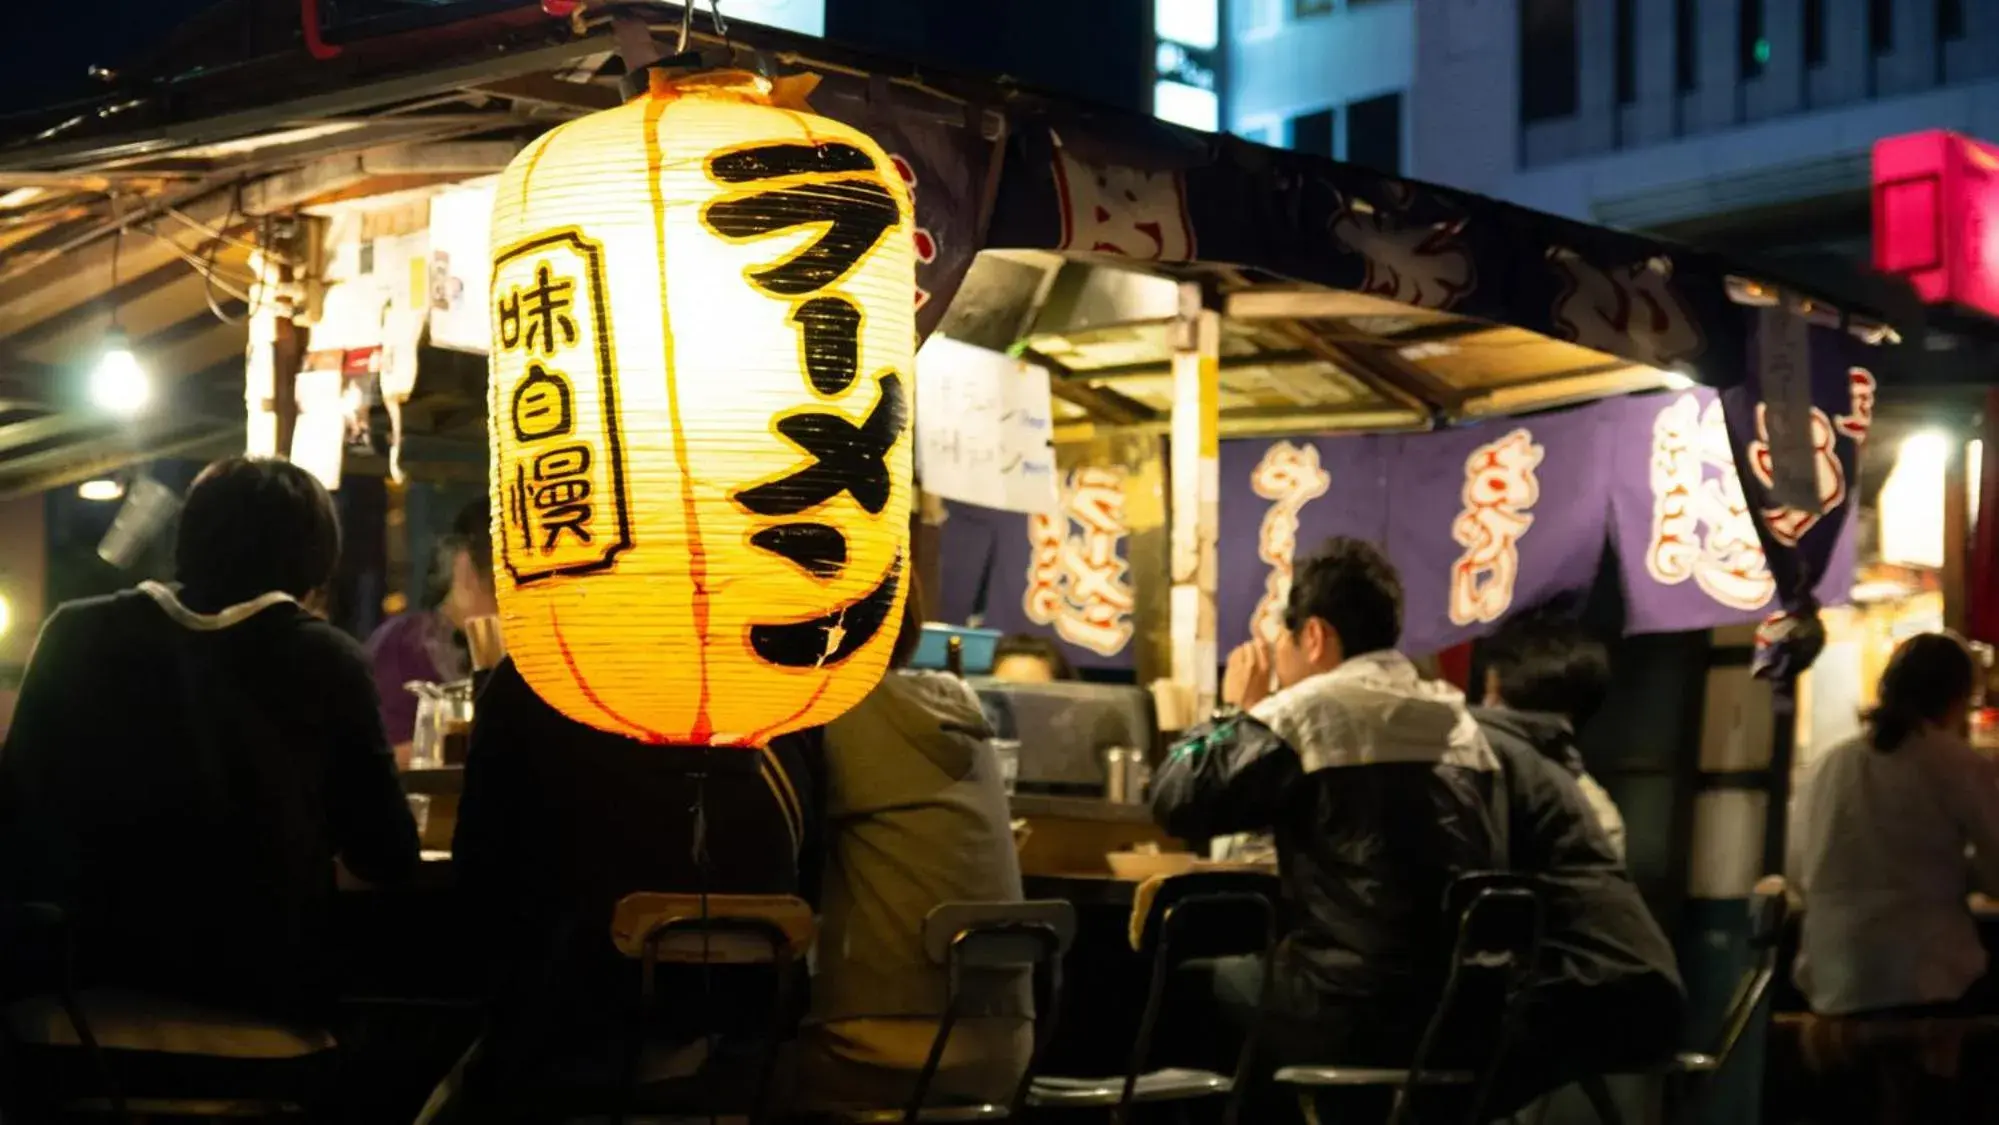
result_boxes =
[368,500,500,759]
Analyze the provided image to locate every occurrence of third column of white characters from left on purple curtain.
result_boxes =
[1449,430,1545,625]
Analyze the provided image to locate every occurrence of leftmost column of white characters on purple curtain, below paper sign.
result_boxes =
[1021,466,1137,655]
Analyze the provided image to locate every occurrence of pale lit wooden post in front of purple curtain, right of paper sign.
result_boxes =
[1169,282,1221,717]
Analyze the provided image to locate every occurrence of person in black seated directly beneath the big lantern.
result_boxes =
[452,639,818,1121]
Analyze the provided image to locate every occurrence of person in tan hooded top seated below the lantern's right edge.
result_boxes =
[800,587,1033,1107]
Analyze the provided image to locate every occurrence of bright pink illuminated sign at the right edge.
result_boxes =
[1873,130,1999,316]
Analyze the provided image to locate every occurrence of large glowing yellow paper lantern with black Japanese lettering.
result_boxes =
[490,72,916,745]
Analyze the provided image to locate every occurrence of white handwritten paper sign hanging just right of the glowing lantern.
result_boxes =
[916,336,1059,512]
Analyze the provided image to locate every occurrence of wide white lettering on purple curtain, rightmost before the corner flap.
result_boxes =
[1645,392,1777,611]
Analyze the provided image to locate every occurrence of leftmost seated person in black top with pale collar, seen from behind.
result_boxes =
[0,458,416,1019]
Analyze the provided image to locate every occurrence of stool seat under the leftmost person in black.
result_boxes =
[6,989,336,1059]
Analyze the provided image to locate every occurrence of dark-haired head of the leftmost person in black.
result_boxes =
[174,458,340,611]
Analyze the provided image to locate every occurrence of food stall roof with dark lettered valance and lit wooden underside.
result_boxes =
[0,2,1867,496]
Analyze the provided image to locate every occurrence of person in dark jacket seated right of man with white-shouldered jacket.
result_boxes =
[1473,615,1687,1113]
